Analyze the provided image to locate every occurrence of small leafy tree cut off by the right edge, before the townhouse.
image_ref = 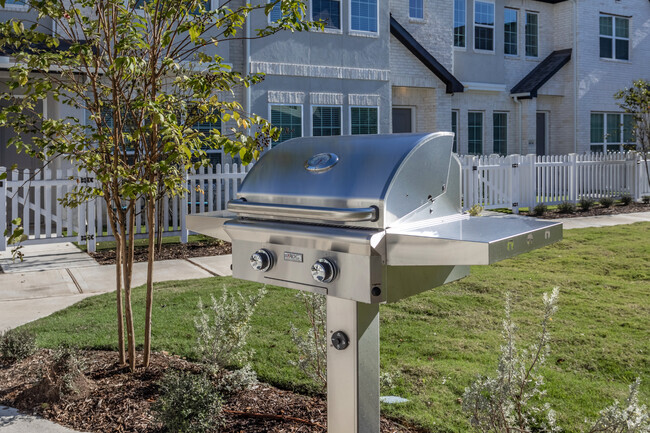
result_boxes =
[614,80,650,191]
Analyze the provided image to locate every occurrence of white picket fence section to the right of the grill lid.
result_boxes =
[460,152,650,212]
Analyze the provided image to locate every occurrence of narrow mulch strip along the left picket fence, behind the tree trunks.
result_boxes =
[88,239,232,265]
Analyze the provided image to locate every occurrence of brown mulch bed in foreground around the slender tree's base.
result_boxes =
[0,349,424,433]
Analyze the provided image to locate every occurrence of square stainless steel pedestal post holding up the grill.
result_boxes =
[327,296,379,433]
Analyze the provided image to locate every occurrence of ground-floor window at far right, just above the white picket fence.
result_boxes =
[591,113,636,152]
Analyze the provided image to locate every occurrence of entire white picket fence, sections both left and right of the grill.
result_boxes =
[0,153,650,251]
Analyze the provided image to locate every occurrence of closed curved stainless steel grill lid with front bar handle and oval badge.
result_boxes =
[228,132,453,229]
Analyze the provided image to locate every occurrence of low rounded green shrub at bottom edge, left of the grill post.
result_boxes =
[151,372,222,433]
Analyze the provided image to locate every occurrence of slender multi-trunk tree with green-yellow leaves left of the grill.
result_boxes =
[0,0,317,370]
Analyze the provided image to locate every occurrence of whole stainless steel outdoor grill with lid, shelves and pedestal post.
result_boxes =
[188,132,562,433]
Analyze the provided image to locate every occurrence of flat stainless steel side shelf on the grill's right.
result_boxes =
[386,217,562,266]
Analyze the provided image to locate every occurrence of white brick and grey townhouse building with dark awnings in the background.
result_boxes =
[0,0,650,172]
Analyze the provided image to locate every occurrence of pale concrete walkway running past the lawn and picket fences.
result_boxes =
[0,212,650,433]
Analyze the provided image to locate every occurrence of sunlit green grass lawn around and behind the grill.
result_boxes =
[28,223,650,432]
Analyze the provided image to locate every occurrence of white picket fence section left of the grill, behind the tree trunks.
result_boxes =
[0,164,250,251]
